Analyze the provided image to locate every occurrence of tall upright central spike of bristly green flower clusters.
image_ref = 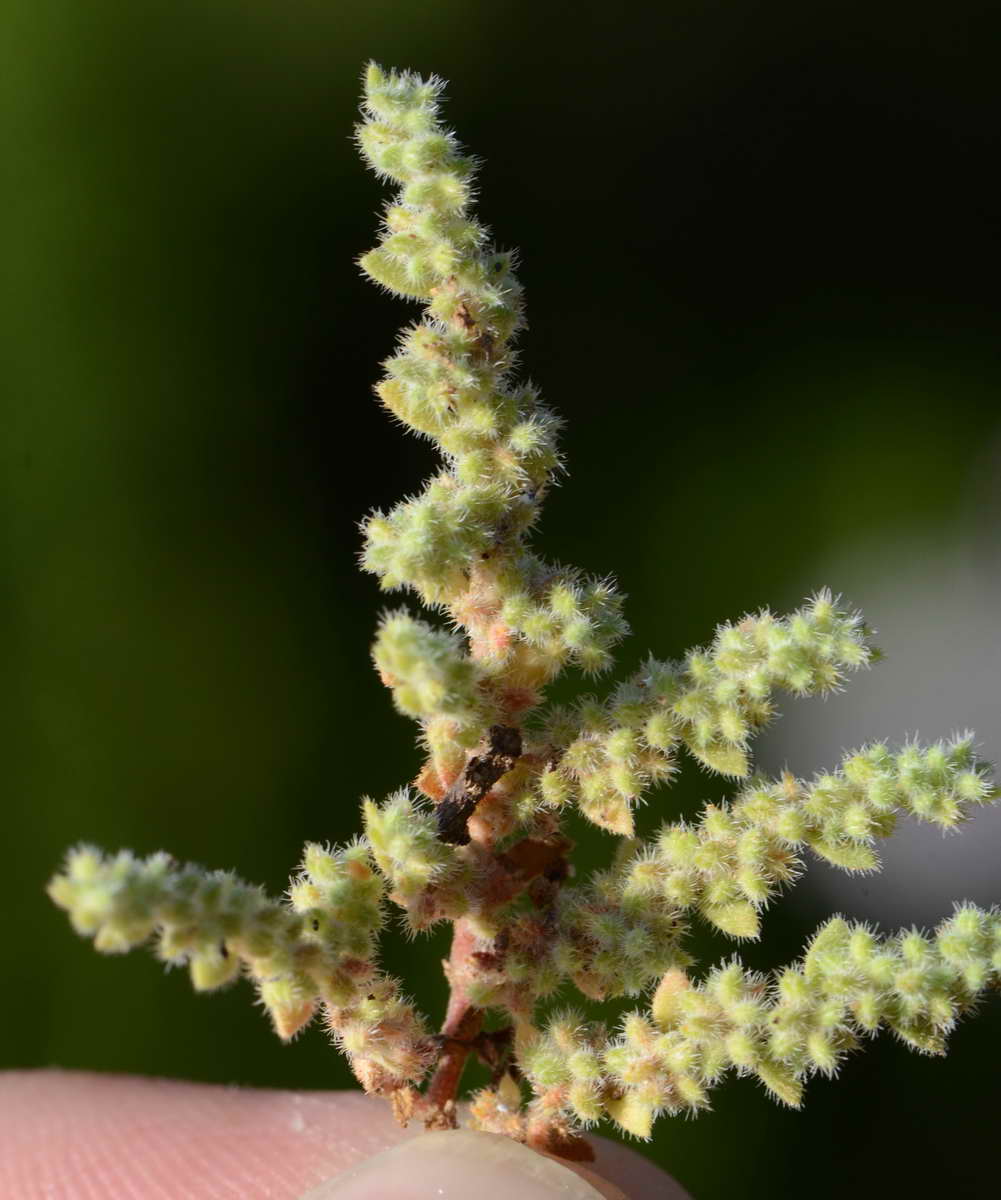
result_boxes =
[358,66,627,715]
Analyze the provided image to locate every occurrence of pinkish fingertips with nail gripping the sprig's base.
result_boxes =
[0,1070,687,1200]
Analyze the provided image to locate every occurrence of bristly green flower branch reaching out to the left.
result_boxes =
[48,842,427,1086]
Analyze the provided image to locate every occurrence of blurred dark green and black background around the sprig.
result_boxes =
[0,0,1001,1200]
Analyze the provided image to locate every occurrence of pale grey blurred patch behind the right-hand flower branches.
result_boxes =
[760,443,1001,928]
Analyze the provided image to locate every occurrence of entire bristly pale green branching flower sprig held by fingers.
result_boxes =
[49,65,1001,1154]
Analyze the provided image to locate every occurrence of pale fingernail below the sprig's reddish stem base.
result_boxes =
[302,1129,601,1200]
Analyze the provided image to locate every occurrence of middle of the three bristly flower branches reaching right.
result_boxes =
[494,736,996,1014]
